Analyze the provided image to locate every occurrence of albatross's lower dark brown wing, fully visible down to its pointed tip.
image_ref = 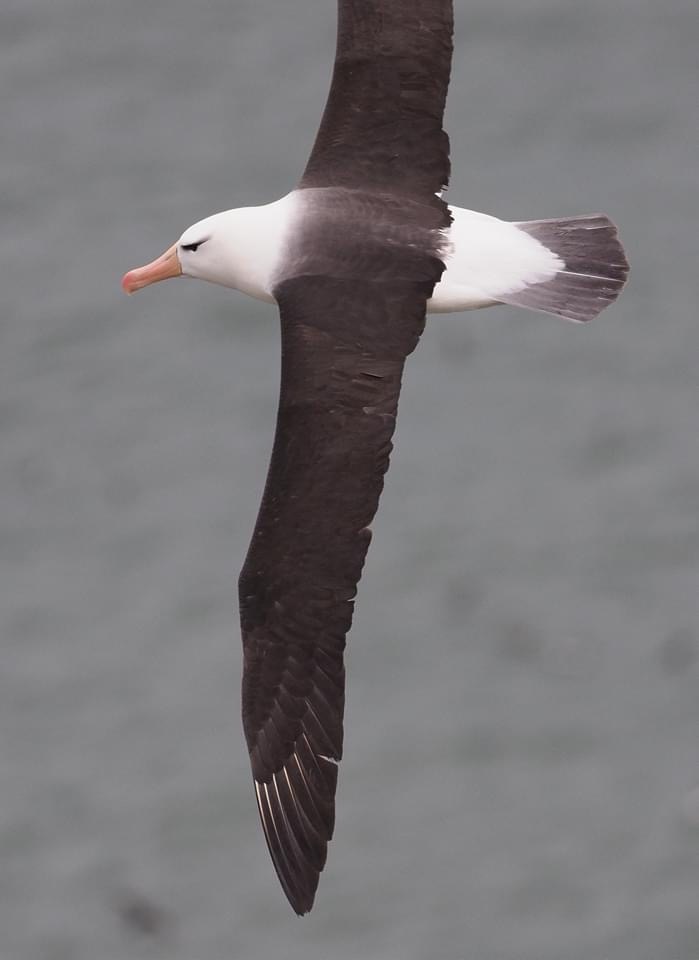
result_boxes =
[240,274,441,914]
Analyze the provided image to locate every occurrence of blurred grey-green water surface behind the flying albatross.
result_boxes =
[0,0,699,960]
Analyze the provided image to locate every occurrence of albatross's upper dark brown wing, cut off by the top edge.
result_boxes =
[300,0,453,195]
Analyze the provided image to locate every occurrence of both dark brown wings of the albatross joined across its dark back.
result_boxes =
[239,0,452,914]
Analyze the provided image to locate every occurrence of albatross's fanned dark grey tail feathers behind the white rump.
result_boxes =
[499,214,629,323]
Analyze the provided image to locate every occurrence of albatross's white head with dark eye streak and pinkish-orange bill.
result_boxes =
[121,210,246,293]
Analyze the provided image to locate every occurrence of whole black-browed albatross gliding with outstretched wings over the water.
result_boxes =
[122,0,628,914]
